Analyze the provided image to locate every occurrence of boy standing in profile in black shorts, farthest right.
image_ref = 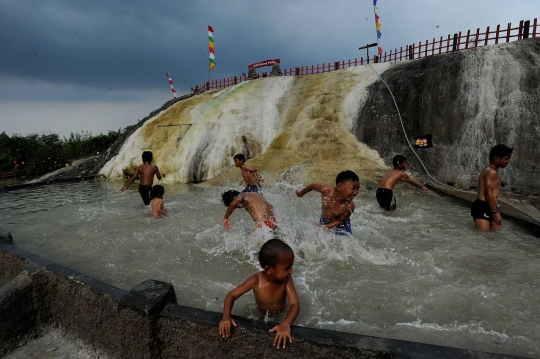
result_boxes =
[471,144,514,232]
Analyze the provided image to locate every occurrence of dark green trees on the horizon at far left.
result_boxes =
[0,129,124,176]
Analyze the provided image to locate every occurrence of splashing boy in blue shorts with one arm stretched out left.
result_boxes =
[296,171,360,235]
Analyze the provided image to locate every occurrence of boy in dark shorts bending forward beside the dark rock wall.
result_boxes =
[376,155,428,211]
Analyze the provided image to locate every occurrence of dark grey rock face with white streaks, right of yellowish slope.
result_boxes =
[353,38,540,195]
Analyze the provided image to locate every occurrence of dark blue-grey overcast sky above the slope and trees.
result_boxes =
[0,0,540,136]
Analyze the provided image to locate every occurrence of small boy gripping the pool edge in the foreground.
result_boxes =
[219,239,300,349]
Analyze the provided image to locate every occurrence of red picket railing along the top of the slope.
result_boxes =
[199,18,540,91]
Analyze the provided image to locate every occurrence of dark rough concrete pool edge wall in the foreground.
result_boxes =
[0,243,519,359]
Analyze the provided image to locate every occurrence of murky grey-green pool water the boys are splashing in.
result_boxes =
[0,179,540,357]
